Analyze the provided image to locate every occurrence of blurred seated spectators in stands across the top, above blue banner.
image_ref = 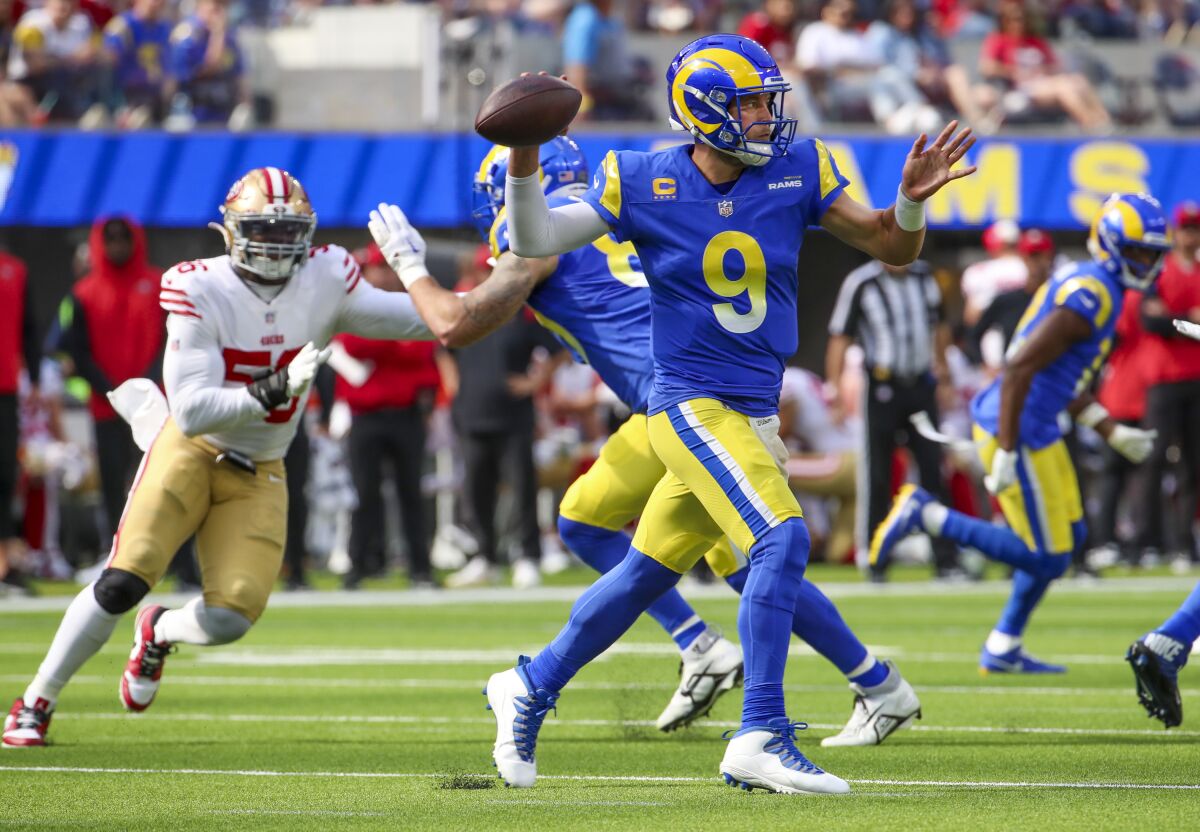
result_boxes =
[0,0,1200,133]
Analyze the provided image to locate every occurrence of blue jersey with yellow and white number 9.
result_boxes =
[583,139,848,415]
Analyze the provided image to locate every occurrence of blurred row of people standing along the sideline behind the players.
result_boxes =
[0,196,1200,593]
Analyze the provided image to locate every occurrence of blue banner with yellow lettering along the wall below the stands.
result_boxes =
[0,131,1200,229]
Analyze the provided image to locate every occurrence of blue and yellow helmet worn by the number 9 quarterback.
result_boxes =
[667,35,796,166]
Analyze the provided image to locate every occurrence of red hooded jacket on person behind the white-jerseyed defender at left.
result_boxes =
[73,217,167,419]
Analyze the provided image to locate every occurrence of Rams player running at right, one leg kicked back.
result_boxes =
[870,193,1169,674]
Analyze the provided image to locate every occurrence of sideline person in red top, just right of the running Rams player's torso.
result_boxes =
[1087,289,1159,569]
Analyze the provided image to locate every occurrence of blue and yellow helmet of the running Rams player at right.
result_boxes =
[1087,193,1171,292]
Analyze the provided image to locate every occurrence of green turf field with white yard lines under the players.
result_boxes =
[0,576,1200,832]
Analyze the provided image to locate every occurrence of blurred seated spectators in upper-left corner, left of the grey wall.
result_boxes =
[0,0,253,130]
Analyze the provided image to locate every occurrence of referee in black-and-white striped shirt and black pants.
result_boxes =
[826,261,958,581]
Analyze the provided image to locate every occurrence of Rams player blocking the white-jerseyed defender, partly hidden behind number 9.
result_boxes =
[373,138,920,746]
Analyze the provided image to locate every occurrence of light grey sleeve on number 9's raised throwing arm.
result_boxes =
[504,173,608,257]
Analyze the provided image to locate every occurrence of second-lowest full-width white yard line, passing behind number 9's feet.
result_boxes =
[44,711,1200,740]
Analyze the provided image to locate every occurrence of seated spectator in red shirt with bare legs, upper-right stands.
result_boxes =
[979,0,1112,133]
